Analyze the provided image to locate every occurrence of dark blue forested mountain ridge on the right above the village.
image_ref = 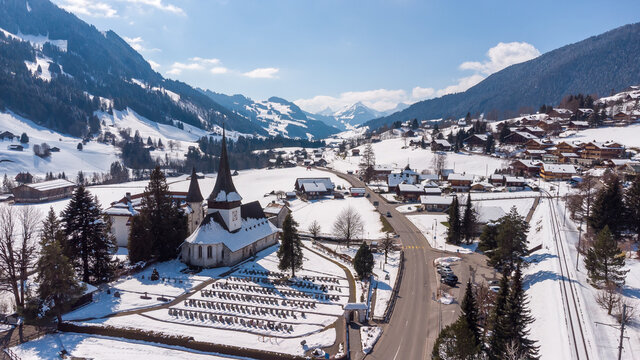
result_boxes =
[365,23,640,129]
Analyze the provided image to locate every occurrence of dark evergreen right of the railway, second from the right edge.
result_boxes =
[587,175,625,239]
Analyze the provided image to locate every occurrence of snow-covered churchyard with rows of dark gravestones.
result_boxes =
[68,246,349,355]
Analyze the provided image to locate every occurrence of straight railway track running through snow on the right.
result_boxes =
[544,191,590,360]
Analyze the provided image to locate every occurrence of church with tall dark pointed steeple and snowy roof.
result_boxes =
[180,131,279,268]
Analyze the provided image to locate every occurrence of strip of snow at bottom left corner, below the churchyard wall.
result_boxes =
[11,333,244,360]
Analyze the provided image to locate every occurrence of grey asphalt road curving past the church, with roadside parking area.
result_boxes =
[323,169,495,360]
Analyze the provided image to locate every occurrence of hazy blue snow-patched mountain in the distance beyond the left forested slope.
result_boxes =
[201,90,340,139]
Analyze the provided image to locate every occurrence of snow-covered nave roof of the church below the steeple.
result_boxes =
[185,213,279,252]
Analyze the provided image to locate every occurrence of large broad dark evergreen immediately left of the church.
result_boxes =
[134,167,187,261]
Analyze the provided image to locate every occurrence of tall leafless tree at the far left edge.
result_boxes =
[0,206,41,308]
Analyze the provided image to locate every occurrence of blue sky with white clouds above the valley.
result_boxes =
[53,0,640,112]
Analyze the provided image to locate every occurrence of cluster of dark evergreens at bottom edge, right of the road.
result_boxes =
[432,263,538,360]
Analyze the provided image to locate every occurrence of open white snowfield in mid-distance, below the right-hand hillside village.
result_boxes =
[326,138,508,176]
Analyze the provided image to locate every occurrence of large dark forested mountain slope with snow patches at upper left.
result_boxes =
[0,0,267,136]
